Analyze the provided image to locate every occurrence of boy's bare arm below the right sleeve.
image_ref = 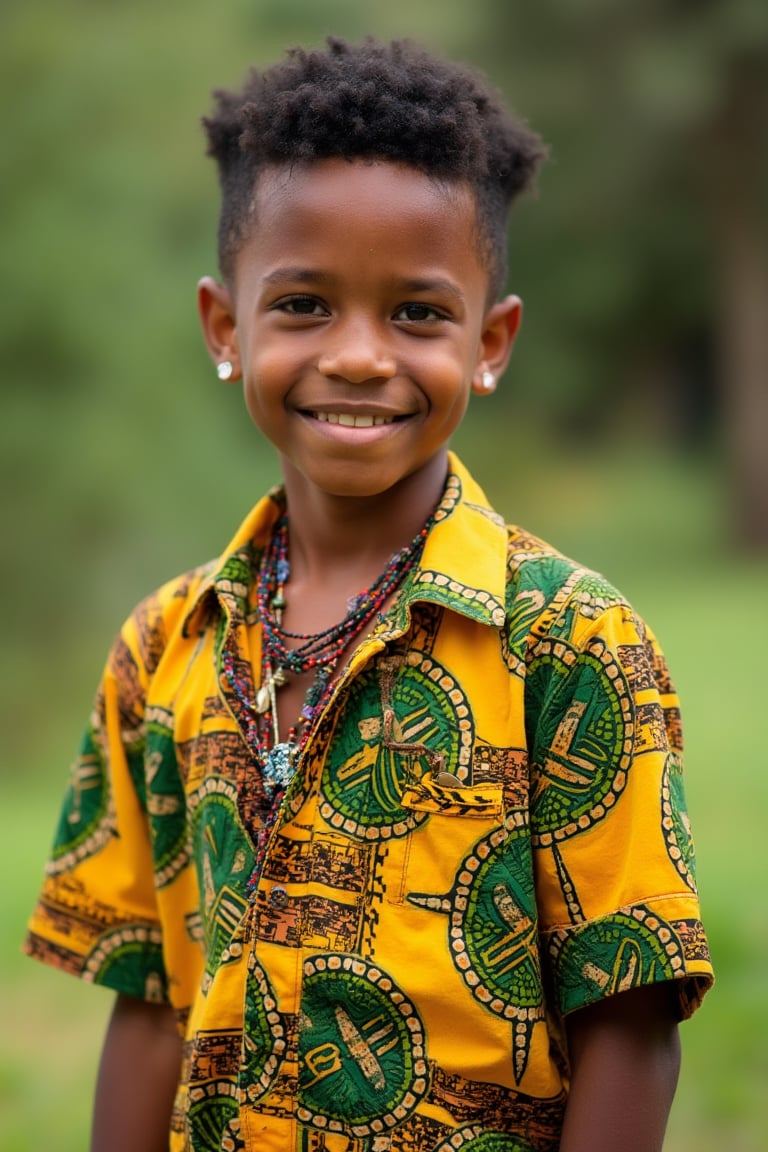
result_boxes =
[560,984,680,1152]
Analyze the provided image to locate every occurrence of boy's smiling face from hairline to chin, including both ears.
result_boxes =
[200,159,520,497]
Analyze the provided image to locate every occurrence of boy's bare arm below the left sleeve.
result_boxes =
[91,994,182,1152]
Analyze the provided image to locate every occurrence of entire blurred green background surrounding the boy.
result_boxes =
[0,0,768,1152]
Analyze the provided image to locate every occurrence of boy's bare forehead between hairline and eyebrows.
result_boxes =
[235,158,487,292]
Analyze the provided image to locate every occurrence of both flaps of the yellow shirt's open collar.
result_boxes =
[184,452,507,635]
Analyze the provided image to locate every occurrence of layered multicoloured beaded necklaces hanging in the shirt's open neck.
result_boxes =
[222,515,433,887]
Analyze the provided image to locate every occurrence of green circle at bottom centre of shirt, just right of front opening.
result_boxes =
[296,953,429,1137]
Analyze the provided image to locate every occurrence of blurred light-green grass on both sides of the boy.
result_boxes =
[0,446,768,1152]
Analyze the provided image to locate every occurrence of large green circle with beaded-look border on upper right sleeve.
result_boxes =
[526,639,634,847]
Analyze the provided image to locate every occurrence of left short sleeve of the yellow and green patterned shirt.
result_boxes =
[24,619,168,1001]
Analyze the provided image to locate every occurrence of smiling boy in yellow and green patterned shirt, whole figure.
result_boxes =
[26,40,712,1152]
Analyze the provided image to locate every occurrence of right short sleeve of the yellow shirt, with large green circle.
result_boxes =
[526,601,713,1017]
